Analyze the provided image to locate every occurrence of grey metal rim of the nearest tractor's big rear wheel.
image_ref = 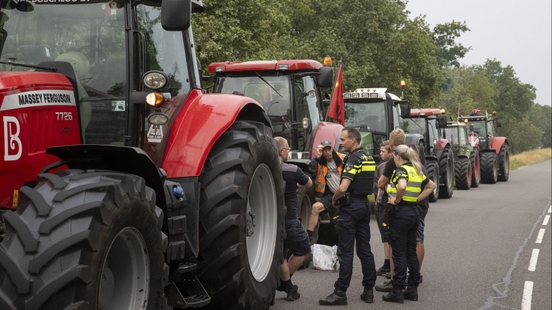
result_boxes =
[246,164,278,282]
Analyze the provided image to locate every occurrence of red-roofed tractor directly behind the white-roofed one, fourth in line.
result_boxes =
[403,109,454,202]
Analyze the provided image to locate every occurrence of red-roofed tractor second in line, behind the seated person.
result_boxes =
[208,58,343,249]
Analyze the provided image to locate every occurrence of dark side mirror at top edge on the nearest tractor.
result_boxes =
[161,0,192,31]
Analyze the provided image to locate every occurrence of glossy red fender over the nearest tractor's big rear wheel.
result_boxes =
[161,91,270,178]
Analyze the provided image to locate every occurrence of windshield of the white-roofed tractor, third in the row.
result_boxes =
[345,100,388,133]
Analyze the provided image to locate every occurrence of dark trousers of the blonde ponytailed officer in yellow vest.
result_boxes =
[389,206,420,288]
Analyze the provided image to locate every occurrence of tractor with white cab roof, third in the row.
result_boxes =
[343,88,410,162]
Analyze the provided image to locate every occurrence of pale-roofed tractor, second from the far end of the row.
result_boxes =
[441,122,481,189]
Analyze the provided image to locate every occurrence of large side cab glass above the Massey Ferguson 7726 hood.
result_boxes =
[0,1,127,144]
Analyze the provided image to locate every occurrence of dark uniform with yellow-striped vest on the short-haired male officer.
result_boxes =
[335,148,376,292]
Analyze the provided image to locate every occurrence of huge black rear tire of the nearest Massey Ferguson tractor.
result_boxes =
[198,122,285,309]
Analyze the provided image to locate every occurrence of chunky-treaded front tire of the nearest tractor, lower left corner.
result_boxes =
[0,170,170,310]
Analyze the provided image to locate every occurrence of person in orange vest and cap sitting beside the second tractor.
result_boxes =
[307,140,343,244]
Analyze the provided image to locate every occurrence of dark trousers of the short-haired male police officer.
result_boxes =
[335,200,376,291]
